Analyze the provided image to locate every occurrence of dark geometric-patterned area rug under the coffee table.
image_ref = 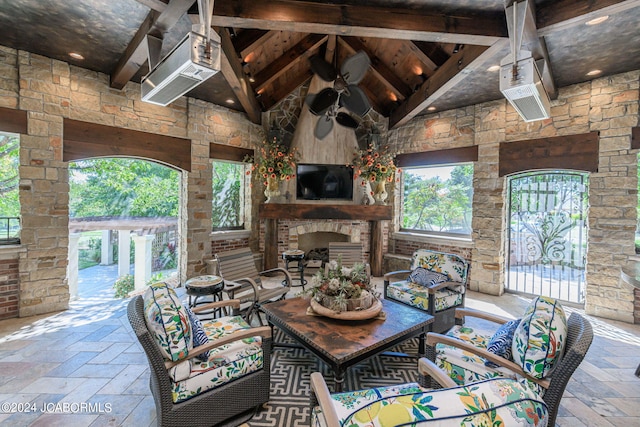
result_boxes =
[248,329,418,427]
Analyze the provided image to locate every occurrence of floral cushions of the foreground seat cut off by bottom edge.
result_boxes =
[313,378,548,427]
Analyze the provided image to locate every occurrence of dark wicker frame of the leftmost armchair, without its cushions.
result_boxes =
[127,290,272,427]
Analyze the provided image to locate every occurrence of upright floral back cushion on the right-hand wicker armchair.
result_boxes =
[512,296,567,378]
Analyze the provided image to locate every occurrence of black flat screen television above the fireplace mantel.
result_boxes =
[296,164,353,200]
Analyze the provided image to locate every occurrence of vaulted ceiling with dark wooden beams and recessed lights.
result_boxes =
[0,0,640,127]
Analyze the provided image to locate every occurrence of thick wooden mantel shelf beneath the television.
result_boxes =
[258,203,393,221]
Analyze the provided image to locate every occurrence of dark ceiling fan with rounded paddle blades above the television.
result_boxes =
[305,51,371,139]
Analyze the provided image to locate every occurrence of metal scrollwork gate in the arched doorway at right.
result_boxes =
[505,171,588,304]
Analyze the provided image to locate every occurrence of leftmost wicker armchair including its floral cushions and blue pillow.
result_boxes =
[127,283,272,426]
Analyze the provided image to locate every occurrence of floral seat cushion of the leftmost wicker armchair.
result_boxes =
[169,316,263,403]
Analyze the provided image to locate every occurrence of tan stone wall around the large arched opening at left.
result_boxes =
[0,48,260,316]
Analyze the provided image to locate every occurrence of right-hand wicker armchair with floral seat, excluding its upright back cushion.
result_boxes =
[427,297,593,426]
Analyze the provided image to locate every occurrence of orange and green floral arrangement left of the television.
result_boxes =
[246,132,297,187]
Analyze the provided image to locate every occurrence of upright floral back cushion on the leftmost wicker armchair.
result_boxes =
[142,282,193,362]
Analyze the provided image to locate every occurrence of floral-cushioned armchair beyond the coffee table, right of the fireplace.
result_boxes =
[384,249,469,332]
